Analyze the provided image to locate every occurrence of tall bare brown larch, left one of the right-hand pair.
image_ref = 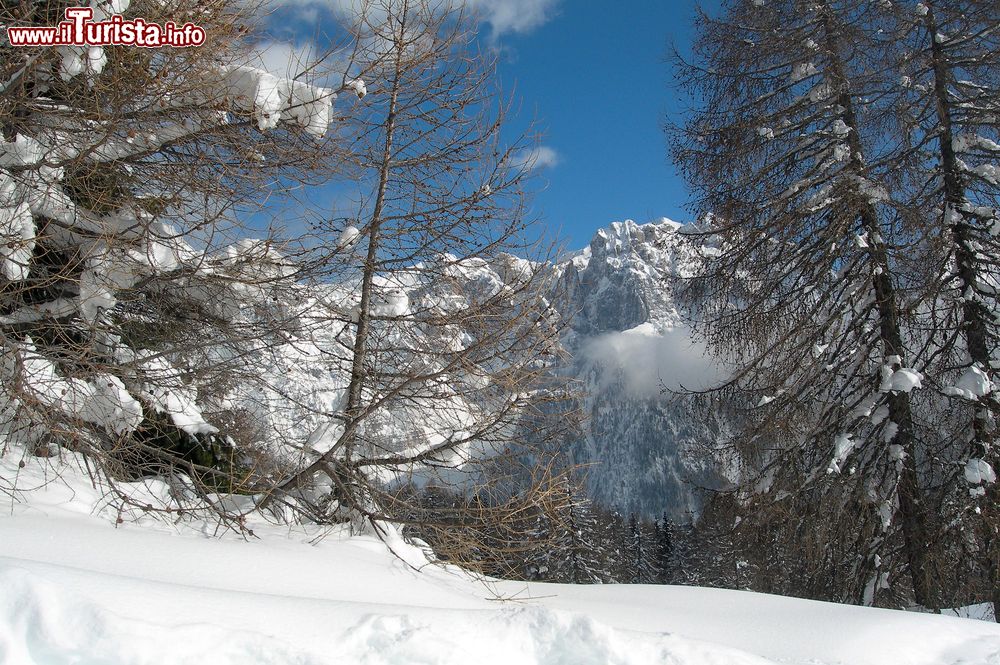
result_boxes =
[673,0,933,605]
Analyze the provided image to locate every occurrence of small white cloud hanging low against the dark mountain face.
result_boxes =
[582,324,723,397]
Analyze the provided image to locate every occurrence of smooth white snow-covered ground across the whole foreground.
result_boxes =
[0,454,1000,665]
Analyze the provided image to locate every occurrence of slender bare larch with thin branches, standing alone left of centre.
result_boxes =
[254,0,573,532]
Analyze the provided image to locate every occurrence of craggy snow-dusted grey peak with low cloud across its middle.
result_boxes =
[557,219,726,521]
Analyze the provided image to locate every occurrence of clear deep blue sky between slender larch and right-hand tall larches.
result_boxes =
[498,0,720,248]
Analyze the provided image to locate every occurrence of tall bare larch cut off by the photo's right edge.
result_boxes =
[889,0,1000,607]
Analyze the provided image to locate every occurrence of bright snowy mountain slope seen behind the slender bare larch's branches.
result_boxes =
[226,255,554,480]
